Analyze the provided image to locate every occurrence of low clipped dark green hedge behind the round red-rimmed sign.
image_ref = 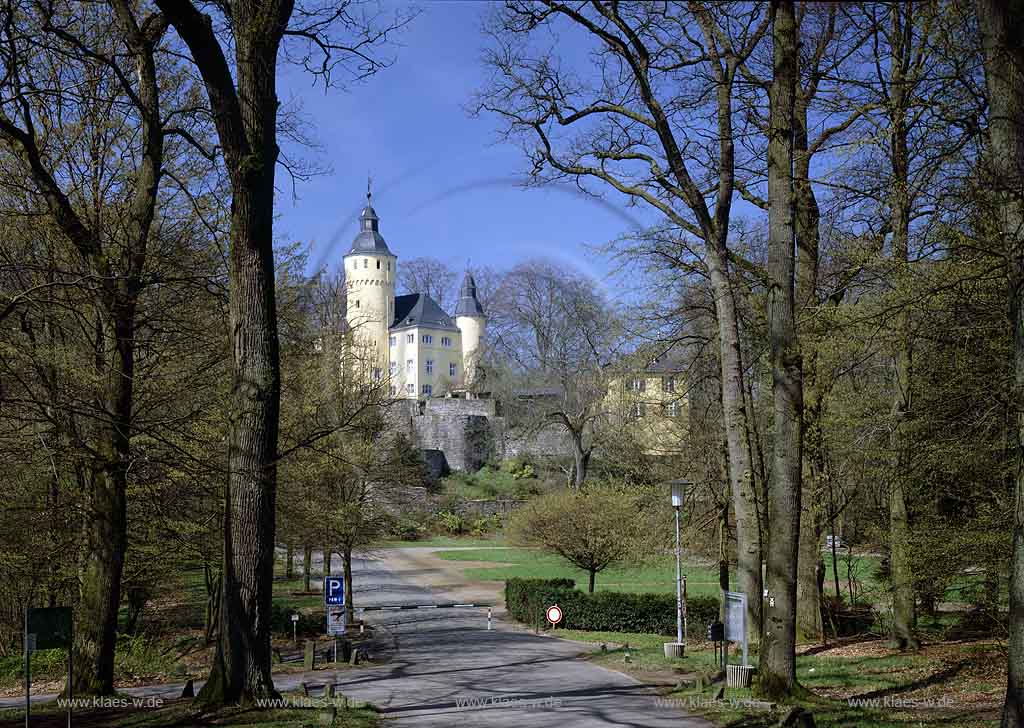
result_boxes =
[505,579,719,637]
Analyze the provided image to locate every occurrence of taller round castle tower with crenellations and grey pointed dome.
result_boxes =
[344,182,398,380]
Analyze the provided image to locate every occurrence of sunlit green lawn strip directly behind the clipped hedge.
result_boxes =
[437,548,719,596]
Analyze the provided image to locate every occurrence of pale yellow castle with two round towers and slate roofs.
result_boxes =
[344,189,487,399]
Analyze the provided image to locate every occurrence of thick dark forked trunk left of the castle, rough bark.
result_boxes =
[157,0,293,706]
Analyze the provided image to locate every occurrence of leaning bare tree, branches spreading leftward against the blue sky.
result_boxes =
[478,0,768,639]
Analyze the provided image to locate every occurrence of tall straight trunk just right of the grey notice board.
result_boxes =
[758,0,804,699]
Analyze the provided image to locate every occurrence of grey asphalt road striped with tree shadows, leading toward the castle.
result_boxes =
[0,554,711,728]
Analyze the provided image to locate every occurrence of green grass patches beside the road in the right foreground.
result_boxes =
[551,630,997,728]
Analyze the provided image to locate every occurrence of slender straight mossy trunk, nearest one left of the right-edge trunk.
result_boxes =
[889,7,919,649]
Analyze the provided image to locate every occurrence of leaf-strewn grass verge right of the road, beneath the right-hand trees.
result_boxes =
[553,630,1006,728]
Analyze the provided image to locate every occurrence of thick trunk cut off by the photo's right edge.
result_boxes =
[978,0,1024,728]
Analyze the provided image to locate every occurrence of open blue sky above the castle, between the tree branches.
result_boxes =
[276,0,655,290]
